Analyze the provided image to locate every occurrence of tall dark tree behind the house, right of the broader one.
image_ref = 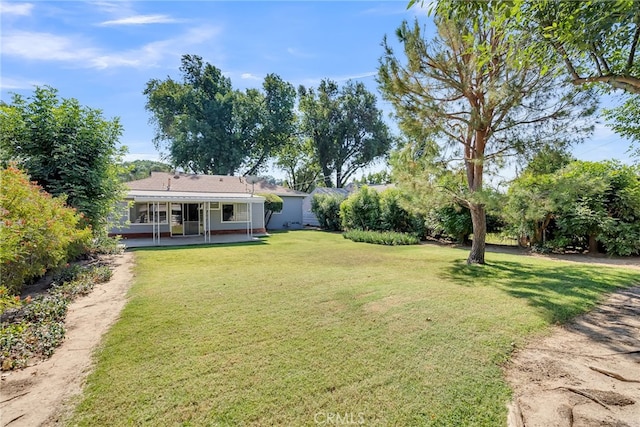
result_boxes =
[298,80,393,188]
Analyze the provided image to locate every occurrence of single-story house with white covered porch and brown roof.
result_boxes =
[110,172,307,242]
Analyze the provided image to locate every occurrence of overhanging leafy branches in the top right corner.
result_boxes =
[422,0,640,147]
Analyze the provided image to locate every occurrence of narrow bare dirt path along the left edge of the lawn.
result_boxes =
[0,252,133,427]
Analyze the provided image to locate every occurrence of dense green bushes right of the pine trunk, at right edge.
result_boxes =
[503,161,640,255]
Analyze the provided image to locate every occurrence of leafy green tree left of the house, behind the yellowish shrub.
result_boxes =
[0,86,126,234]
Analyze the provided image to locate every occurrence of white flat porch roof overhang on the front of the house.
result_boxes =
[127,190,264,203]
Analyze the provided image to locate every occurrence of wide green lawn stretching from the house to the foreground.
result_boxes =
[71,231,640,426]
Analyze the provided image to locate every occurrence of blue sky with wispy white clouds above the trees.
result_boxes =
[0,0,629,179]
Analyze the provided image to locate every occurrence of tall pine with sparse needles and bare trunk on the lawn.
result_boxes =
[378,8,595,264]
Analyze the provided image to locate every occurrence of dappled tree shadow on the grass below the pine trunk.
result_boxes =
[444,260,640,323]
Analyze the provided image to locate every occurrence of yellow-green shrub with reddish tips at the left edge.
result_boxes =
[0,166,91,295]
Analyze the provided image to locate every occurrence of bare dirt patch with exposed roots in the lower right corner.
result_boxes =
[506,286,640,427]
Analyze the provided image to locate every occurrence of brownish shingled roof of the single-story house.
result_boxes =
[126,172,307,197]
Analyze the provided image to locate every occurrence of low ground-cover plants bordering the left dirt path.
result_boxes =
[0,265,112,371]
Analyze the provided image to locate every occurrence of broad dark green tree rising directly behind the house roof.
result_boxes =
[144,55,296,175]
